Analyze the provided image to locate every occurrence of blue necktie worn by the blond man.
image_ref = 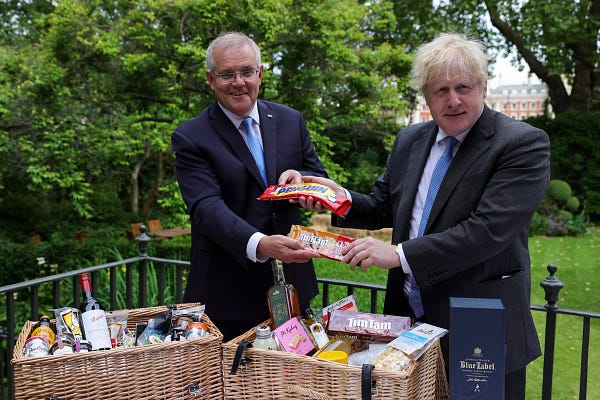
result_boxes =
[408,136,458,318]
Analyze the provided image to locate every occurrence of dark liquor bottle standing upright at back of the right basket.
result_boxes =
[267,260,300,328]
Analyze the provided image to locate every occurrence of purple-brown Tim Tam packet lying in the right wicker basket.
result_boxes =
[327,310,412,342]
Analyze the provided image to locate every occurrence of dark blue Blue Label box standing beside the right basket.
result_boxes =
[449,297,506,400]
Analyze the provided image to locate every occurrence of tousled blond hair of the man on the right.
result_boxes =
[410,33,488,92]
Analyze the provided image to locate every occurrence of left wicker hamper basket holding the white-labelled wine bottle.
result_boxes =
[11,303,223,400]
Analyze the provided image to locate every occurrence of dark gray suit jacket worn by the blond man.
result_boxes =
[333,107,550,373]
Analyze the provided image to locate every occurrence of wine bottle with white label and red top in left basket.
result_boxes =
[79,274,112,350]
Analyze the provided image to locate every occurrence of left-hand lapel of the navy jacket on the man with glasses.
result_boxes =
[209,103,268,188]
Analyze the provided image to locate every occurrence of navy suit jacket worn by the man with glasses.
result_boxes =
[171,100,326,323]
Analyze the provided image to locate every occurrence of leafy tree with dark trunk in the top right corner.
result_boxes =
[390,0,600,114]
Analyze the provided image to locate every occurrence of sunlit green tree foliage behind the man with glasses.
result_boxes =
[0,0,410,231]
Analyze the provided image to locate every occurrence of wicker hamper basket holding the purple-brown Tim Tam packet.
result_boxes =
[223,322,449,400]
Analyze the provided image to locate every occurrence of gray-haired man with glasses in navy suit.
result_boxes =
[171,32,327,341]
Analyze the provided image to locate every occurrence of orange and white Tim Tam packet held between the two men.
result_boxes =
[288,225,356,261]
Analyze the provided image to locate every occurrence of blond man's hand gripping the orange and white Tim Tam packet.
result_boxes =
[342,237,400,271]
